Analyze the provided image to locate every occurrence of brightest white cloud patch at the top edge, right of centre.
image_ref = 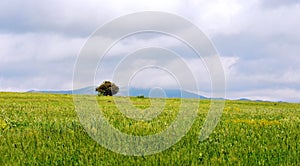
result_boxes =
[179,0,259,37]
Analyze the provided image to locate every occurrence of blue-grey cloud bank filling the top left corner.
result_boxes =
[0,0,112,36]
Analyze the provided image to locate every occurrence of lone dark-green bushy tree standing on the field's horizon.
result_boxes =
[96,81,119,96]
